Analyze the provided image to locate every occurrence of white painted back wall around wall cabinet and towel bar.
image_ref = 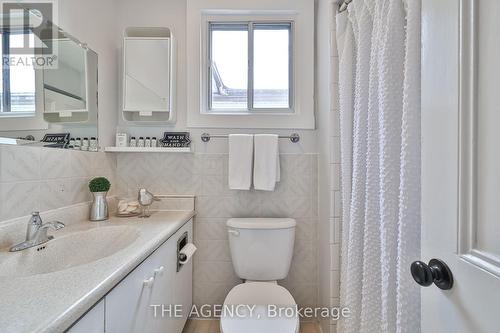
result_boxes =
[114,0,317,153]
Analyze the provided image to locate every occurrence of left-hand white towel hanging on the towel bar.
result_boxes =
[228,134,253,190]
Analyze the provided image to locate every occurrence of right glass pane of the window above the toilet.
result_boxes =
[253,23,291,108]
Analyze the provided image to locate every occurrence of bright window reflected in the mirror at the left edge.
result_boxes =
[0,30,35,117]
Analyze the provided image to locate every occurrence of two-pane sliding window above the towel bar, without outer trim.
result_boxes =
[207,22,293,112]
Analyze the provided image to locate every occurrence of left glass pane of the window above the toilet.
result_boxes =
[210,24,248,110]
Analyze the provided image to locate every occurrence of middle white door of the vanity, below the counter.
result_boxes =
[105,250,157,333]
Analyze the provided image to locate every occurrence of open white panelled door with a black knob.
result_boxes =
[422,0,500,333]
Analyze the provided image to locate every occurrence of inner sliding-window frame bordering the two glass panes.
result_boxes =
[203,19,295,114]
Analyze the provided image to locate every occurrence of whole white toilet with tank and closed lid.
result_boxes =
[220,218,299,333]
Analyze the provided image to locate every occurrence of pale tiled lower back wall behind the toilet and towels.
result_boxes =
[117,153,318,306]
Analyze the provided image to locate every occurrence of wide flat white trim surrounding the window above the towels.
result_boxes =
[186,4,316,130]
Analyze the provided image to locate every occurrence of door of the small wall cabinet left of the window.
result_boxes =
[123,38,170,111]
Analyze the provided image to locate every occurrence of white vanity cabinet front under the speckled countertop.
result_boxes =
[68,220,193,333]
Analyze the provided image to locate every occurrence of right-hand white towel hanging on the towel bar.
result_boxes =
[253,134,280,191]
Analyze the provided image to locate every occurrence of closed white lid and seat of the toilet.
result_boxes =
[220,282,299,333]
